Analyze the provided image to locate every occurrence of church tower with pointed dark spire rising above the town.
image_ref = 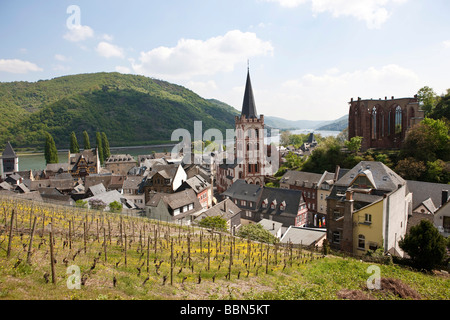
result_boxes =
[235,70,265,185]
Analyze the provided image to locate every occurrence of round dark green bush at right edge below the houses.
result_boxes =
[399,220,446,270]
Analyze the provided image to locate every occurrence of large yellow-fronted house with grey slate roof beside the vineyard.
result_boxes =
[327,161,412,256]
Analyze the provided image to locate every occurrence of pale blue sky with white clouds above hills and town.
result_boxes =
[0,0,450,120]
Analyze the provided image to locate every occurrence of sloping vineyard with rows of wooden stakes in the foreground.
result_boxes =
[0,198,449,299]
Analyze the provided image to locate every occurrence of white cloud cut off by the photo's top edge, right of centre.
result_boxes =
[266,0,408,29]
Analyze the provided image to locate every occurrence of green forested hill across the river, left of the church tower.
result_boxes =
[0,73,241,149]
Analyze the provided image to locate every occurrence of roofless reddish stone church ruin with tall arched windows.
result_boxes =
[348,95,424,151]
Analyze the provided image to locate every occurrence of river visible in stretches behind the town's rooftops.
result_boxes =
[14,129,340,171]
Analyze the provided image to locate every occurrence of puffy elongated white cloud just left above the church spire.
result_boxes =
[132,30,274,79]
